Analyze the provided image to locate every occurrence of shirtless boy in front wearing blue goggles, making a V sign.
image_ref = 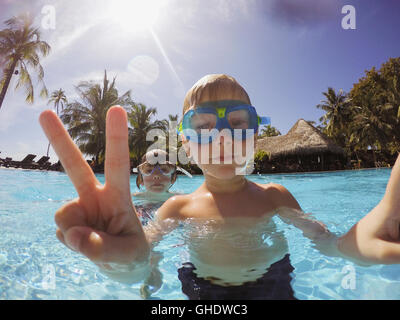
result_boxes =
[40,75,400,299]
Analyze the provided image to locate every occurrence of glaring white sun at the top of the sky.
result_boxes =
[107,0,165,32]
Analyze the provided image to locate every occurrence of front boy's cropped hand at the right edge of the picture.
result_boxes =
[338,155,400,264]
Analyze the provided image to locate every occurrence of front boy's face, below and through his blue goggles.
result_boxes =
[184,100,257,179]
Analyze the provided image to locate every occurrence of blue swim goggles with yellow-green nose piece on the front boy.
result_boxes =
[178,100,271,144]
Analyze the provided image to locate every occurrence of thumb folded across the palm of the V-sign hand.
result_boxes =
[64,226,149,263]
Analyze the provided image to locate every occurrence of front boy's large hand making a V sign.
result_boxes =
[39,106,150,264]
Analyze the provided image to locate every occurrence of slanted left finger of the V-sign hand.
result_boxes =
[39,110,99,197]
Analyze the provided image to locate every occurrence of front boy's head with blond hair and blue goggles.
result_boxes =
[182,74,257,179]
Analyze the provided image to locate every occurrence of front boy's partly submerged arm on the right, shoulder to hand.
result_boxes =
[276,155,400,265]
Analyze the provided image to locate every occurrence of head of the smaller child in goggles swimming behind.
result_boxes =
[136,149,177,193]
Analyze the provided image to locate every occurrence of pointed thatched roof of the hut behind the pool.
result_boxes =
[256,119,344,158]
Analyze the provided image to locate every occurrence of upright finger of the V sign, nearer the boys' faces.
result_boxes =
[105,106,130,195]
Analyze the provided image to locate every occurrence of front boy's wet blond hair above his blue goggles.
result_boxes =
[183,74,251,114]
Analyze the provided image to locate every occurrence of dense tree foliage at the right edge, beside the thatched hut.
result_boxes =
[317,58,400,157]
